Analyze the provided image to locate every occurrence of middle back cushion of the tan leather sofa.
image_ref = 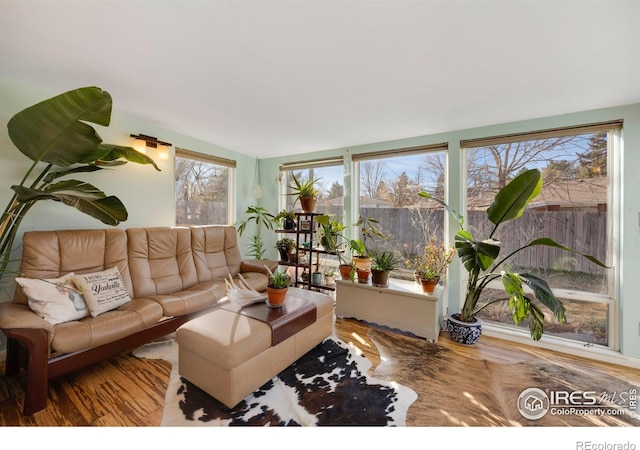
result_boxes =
[127,227,198,298]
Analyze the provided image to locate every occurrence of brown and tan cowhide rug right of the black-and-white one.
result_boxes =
[367,329,640,427]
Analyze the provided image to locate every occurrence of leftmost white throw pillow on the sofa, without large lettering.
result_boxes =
[16,272,89,325]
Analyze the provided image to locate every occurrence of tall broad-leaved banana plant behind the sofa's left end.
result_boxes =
[0,87,160,278]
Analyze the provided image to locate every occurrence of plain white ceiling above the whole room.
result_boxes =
[0,0,640,158]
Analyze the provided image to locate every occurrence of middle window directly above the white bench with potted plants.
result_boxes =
[353,144,447,279]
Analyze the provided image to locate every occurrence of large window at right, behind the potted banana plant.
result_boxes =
[463,123,620,346]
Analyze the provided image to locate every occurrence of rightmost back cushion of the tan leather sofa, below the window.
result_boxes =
[191,225,242,283]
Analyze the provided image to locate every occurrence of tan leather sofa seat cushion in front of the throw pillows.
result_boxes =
[51,299,163,353]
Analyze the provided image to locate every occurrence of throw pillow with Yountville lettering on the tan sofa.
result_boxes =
[73,267,131,317]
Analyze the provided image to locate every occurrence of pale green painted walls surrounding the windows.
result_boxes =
[0,78,640,368]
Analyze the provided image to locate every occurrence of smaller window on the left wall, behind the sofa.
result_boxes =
[175,149,235,225]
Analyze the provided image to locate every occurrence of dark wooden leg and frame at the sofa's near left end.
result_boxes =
[5,328,49,416]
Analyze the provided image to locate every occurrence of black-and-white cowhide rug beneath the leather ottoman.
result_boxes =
[133,337,418,426]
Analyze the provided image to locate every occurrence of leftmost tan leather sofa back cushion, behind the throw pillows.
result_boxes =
[13,229,133,304]
